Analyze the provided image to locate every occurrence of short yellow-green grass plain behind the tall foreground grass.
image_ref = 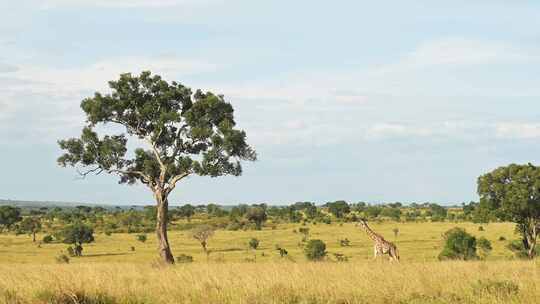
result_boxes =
[0,222,519,264]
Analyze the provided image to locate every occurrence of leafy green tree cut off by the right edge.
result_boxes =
[478,164,540,259]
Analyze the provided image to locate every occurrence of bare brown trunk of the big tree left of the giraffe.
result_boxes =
[154,190,174,264]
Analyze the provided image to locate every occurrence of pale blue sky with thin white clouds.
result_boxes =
[0,0,540,204]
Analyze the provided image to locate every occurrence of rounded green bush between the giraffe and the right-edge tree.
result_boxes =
[439,227,478,260]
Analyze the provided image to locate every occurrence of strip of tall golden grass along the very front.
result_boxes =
[0,261,540,304]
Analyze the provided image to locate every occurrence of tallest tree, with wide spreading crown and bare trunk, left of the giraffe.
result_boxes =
[58,72,256,263]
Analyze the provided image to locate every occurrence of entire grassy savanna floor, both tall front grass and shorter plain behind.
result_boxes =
[0,222,540,303]
